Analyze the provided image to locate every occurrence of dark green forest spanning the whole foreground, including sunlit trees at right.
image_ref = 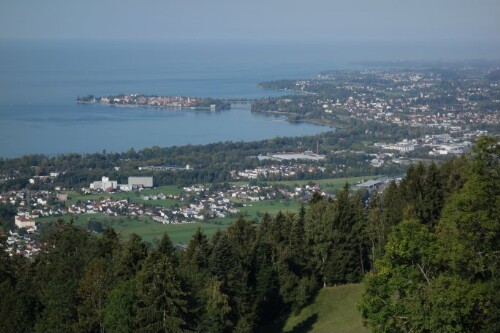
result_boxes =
[0,137,500,332]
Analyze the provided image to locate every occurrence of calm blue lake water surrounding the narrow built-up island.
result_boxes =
[0,41,491,157]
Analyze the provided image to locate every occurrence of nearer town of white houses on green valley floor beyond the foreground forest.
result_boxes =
[0,167,393,257]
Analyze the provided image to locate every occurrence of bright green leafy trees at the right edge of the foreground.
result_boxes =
[360,138,500,332]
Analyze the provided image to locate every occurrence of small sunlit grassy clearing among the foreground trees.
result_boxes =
[283,284,370,333]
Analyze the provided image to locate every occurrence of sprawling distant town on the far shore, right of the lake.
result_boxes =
[252,63,500,132]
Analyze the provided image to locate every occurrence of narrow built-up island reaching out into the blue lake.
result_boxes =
[76,94,231,111]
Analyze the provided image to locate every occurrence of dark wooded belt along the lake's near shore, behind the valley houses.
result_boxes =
[0,120,437,192]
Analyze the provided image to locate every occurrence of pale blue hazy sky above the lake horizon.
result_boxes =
[0,0,500,44]
